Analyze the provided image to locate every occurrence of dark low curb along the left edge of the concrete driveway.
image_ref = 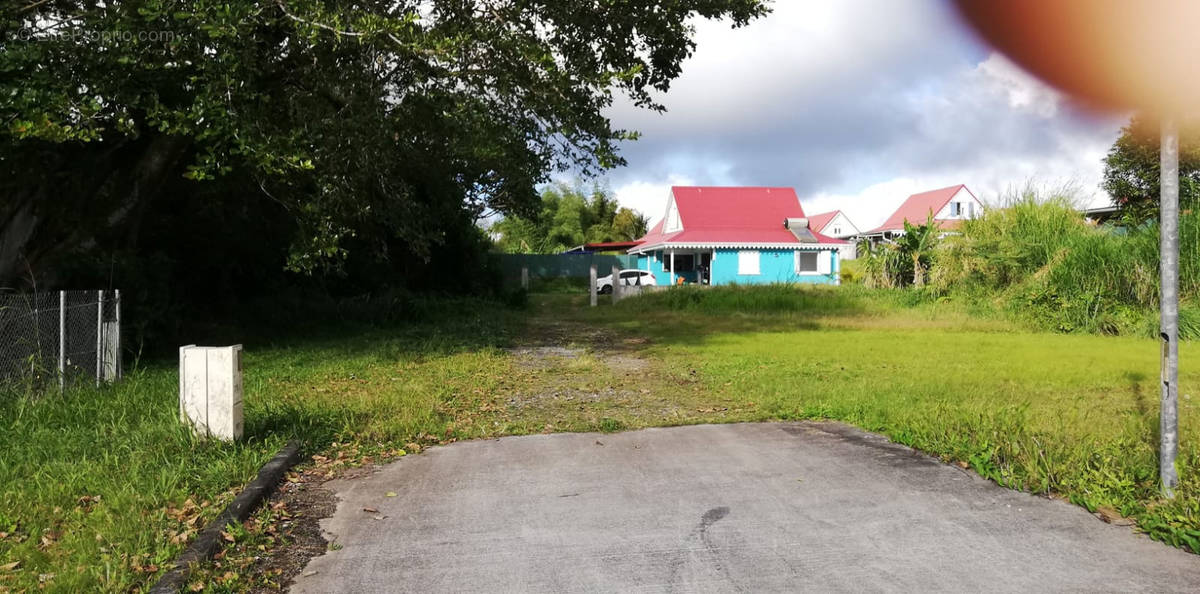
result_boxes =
[150,442,300,594]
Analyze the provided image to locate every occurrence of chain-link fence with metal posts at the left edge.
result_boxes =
[0,290,121,386]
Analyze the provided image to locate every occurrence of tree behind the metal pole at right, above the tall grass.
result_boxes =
[1102,115,1200,223]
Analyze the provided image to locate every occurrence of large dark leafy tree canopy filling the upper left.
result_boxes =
[0,0,767,286]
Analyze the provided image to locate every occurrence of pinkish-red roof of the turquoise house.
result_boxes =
[640,186,845,246]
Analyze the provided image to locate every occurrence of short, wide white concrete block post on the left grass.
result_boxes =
[179,344,242,442]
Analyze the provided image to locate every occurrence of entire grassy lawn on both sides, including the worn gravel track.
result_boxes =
[0,287,1200,592]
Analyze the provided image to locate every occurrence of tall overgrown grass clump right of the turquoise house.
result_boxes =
[930,191,1200,337]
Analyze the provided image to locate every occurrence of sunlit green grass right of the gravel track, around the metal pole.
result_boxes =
[584,286,1200,552]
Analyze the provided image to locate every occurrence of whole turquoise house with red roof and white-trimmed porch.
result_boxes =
[629,186,848,284]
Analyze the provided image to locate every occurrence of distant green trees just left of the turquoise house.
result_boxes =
[491,182,647,253]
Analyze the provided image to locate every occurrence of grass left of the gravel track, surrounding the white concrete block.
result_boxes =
[0,302,525,592]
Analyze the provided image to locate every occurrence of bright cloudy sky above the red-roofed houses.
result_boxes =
[607,0,1126,229]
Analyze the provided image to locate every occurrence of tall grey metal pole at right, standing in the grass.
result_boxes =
[1158,116,1180,497]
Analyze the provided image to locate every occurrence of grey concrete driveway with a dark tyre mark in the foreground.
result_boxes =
[293,422,1200,593]
